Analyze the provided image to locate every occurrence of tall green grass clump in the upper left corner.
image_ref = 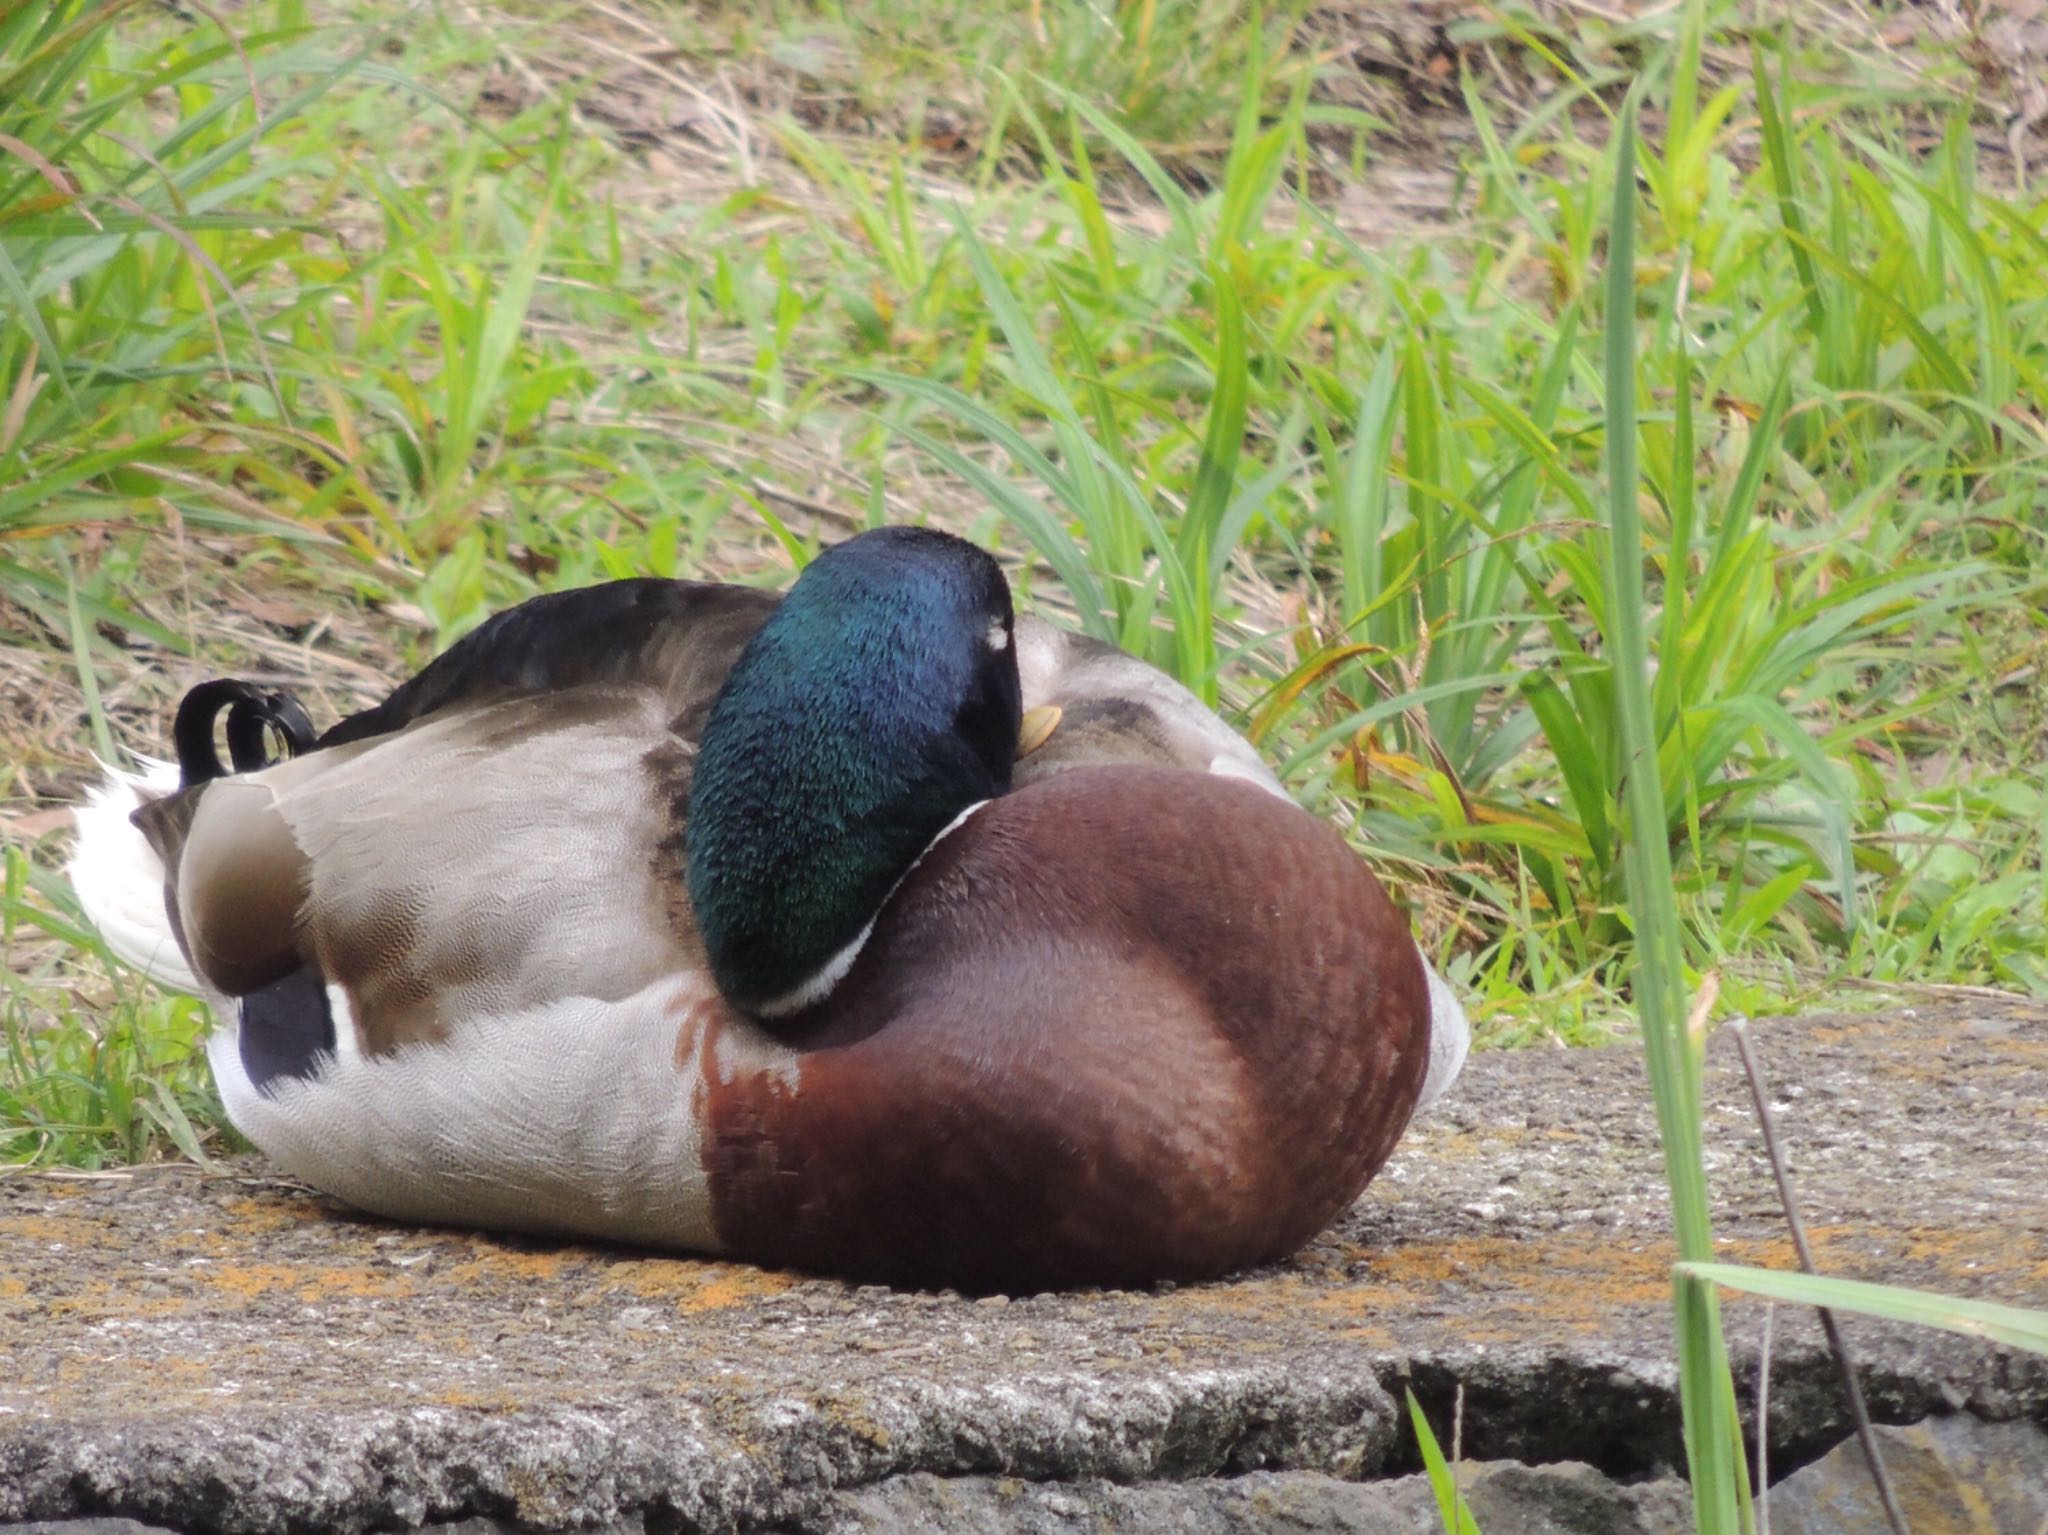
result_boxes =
[0,0,329,643]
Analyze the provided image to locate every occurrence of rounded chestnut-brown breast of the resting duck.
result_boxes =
[705,768,1430,1289]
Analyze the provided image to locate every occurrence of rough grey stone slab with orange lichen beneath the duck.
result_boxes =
[0,1001,2048,1531]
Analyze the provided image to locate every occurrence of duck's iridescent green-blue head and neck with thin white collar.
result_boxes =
[688,528,1020,1017]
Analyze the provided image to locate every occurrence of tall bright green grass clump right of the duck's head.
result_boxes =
[854,60,2044,1027]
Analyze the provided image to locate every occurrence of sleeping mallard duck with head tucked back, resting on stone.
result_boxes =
[72,528,1466,1289]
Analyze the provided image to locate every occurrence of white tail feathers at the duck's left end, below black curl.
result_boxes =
[66,757,199,993]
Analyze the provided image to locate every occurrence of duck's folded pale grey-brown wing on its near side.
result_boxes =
[143,684,694,1039]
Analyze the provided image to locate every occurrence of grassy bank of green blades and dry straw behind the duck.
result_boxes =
[0,0,2048,1165]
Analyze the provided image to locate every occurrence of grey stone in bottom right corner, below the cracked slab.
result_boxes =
[1772,1414,2048,1535]
